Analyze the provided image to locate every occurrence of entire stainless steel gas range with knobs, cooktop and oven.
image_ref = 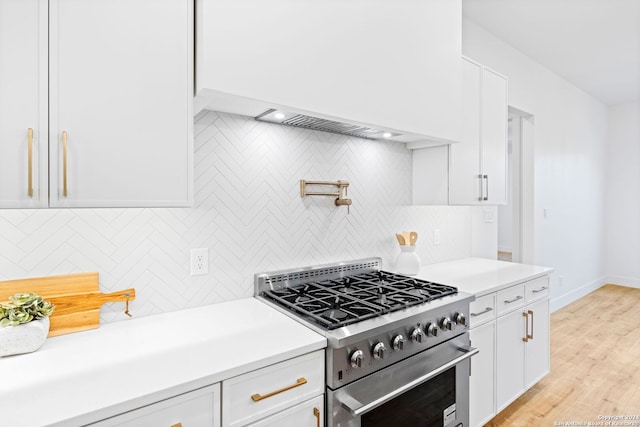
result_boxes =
[255,258,478,427]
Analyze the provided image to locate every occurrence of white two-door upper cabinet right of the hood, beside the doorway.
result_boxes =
[449,58,508,205]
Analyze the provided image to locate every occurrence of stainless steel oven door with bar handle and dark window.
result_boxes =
[327,332,478,427]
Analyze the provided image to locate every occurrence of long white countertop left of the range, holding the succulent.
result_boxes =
[0,298,326,427]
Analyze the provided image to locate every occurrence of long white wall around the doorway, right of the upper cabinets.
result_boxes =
[462,19,607,309]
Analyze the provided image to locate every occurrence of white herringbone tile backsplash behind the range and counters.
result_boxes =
[0,111,471,322]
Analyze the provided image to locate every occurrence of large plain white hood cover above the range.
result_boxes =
[195,0,461,148]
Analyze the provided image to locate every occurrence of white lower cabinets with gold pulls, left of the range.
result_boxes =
[90,350,325,427]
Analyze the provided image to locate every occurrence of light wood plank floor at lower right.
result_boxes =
[487,285,640,427]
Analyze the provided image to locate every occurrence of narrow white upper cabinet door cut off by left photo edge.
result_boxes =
[0,0,48,208]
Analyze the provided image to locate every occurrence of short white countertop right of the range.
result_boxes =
[416,258,553,297]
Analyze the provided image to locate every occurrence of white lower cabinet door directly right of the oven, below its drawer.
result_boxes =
[469,321,496,427]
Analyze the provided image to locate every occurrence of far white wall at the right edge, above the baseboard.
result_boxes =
[605,102,640,287]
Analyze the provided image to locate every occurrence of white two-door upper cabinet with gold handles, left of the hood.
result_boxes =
[0,0,194,208]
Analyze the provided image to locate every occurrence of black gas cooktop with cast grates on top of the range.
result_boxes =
[260,270,458,330]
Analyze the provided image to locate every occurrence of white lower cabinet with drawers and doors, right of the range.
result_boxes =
[469,276,550,427]
